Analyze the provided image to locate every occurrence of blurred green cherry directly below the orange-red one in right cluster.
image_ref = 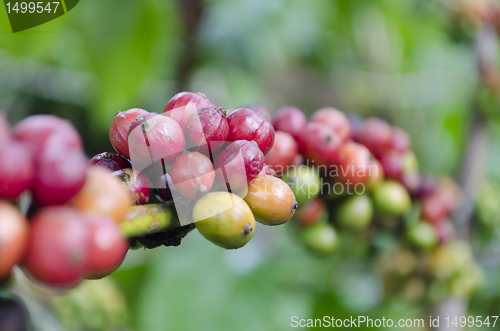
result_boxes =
[334,194,373,230]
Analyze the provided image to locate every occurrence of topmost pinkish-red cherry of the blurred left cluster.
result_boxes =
[13,115,82,154]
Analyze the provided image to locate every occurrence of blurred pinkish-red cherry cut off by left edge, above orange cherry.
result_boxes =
[0,140,35,199]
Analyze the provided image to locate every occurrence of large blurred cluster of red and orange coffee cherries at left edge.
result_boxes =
[0,114,132,288]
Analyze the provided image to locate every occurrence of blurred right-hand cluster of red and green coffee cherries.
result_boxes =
[260,106,482,304]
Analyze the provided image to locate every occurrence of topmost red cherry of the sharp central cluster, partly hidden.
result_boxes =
[163,92,215,129]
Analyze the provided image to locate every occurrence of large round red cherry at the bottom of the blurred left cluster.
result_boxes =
[24,206,90,287]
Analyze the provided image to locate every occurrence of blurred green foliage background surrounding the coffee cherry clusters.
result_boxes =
[0,0,500,331]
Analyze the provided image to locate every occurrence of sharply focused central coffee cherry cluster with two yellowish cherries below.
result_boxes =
[102,92,297,249]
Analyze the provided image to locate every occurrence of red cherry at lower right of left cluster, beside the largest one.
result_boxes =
[84,214,129,279]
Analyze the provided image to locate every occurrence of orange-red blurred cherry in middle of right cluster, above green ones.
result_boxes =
[337,142,372,185]
